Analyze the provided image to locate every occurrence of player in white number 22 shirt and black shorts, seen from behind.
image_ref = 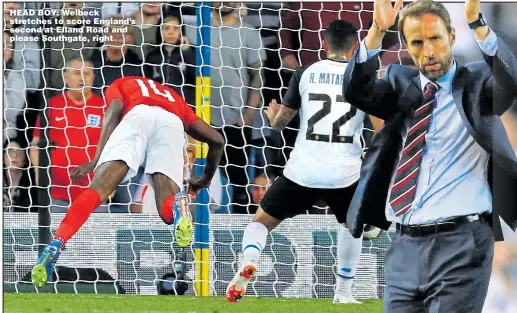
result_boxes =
[226,20,378,303]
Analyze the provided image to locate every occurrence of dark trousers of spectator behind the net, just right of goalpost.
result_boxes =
[219,126,251,213]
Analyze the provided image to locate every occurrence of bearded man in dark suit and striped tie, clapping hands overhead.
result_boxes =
[343,0,517,313]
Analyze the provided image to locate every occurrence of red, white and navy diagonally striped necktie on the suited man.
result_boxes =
[390,82,440,216]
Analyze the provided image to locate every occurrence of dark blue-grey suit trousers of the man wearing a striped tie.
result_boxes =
[384,220,494,313]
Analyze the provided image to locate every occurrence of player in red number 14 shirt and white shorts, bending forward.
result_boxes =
[31,77,224,287]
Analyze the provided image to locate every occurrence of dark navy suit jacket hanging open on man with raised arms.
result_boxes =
[343,38,517,240]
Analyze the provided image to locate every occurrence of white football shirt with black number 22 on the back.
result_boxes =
[282,60,365,189]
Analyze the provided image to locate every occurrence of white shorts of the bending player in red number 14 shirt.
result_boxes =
[96,105,185,190]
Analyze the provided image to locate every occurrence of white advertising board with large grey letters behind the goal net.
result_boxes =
[3,213,392,298]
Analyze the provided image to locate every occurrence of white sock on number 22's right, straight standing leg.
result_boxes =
[336,227,363,296]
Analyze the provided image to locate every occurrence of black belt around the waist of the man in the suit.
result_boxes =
[396,214,482,237]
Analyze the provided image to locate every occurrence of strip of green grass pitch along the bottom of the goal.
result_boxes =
[4,293,382,313]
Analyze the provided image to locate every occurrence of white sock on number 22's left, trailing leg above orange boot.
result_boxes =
[242,222,268,264]
